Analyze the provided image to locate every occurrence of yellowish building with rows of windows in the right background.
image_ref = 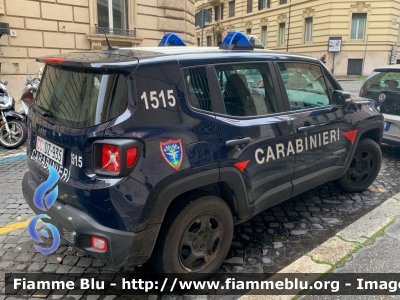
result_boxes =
[196,0,400,76]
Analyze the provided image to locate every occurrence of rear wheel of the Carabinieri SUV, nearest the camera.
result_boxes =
[153,196,234,278]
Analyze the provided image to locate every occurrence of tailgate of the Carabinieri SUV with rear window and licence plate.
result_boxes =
[28,66,128,211]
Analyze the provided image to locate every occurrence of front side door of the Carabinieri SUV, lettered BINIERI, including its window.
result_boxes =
[277,61,354,196]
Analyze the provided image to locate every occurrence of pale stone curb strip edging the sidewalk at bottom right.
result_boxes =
[239,193,400,300]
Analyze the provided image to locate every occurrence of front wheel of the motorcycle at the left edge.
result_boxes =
[0,119,28,149]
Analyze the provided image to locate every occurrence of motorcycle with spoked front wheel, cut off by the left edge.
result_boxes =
[0,81,28,149]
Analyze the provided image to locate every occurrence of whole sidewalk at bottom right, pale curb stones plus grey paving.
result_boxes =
[240,193,400,300]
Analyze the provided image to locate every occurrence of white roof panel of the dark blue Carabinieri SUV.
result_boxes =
[37,46,318,73]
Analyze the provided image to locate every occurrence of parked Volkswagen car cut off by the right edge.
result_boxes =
[360,65,400,146]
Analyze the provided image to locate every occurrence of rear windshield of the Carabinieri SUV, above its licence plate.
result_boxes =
[35,66,128,128]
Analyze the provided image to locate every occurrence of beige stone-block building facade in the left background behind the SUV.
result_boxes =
[0,0,195,99]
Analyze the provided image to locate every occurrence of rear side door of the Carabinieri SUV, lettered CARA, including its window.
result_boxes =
[214,62,295,211]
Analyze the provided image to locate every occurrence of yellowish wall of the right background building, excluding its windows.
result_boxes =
[196,0,400,76]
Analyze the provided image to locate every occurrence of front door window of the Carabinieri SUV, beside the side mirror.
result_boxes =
[278,62,333,110]
